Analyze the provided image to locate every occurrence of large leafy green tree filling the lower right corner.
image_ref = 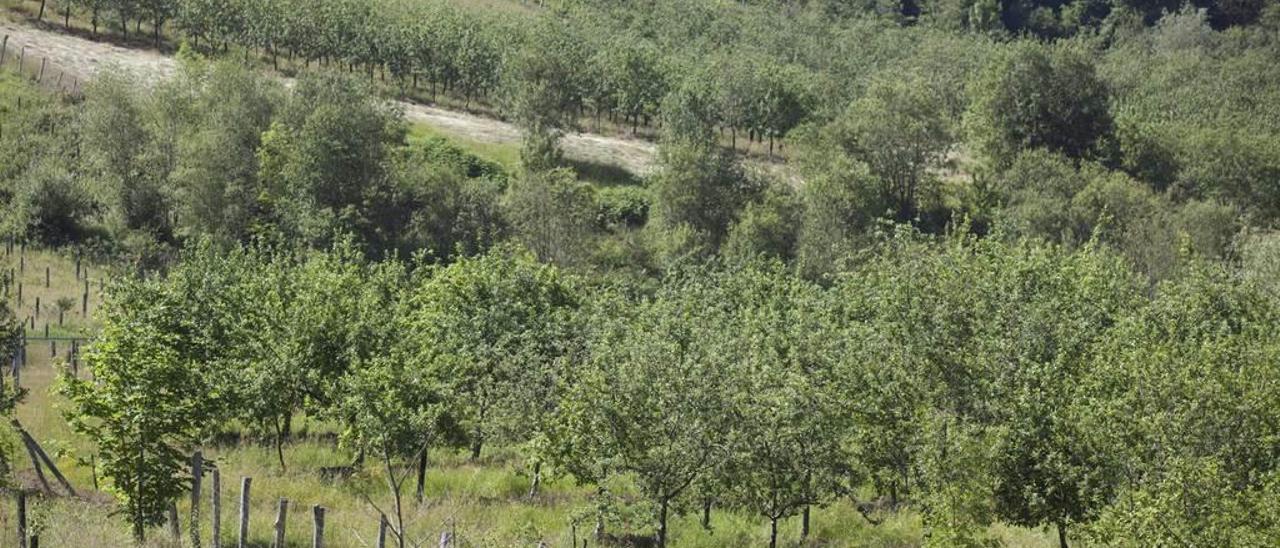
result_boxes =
[1069,262,1280,545]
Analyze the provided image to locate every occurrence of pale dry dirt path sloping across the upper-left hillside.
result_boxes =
[0,19,657,175]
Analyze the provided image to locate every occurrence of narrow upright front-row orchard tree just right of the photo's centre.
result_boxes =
[724,264,855,548]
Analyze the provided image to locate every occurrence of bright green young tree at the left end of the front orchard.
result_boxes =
[60,282,223,542]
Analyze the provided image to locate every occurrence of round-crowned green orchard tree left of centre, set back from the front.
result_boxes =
[408,247,576,460]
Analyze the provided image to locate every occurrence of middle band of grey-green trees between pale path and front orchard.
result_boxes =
[0,34,1259,284]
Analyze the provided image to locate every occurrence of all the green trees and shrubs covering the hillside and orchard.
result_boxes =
[0,0,1280,547]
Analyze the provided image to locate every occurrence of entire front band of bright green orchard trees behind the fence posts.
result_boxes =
[63,232,1280,547]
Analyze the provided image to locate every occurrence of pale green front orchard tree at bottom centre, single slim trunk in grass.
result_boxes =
[564,274,733,547]
